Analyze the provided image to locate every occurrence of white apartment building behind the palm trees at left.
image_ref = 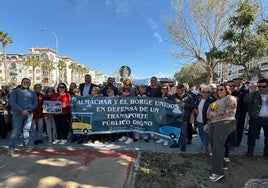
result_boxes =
[0,47,106,86]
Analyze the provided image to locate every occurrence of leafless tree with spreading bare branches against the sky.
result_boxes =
[164,0,235,83]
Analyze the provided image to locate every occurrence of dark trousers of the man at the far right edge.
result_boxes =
[248,117,268,155]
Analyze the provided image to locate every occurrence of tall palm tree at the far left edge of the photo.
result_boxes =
[0,31,13,83]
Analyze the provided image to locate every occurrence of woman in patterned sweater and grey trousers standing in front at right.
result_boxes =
[207,84,237,181]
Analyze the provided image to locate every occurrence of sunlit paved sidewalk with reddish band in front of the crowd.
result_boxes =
[0,132,264,188]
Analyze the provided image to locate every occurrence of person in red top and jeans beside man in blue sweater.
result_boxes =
[31,84,45,145]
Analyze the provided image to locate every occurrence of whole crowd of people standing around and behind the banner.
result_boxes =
[0,75,268,181]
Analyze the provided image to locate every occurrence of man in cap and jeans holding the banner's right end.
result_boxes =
[169,84,195,152]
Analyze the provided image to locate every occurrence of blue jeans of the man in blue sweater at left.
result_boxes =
[9,113,33,148]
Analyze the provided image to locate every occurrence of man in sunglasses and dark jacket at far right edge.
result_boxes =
[244,79,268,157]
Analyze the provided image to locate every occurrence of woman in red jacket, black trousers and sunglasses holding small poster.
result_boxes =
[50,83,72,145]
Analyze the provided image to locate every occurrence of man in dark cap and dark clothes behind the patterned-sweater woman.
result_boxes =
[233,77,249,146]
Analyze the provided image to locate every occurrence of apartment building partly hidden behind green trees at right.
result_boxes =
[215,56,268,84]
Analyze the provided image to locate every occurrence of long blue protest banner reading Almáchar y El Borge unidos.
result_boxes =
[72,96,184,139]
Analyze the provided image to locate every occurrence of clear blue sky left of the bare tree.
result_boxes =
[0,0,179,78]
